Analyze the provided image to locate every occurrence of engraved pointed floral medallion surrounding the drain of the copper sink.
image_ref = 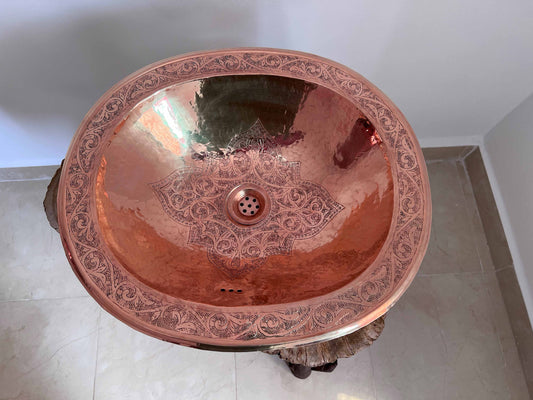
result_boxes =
[151,123,344,278]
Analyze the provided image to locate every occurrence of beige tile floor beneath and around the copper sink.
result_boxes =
[0,161,529,400]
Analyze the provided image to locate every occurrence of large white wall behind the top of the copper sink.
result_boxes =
[0,0,533,167]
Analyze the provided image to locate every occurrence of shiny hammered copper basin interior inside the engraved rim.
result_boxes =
[96,75,394,307]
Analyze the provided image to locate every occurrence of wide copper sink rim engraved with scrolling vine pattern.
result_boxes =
[58,48,431,351]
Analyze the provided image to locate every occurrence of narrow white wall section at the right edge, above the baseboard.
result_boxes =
[484,95,533,321]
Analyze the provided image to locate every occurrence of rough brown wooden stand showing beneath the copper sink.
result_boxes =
[43,164,385,379]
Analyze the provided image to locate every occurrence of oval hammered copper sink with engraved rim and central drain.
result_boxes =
[58,49,431,350]
